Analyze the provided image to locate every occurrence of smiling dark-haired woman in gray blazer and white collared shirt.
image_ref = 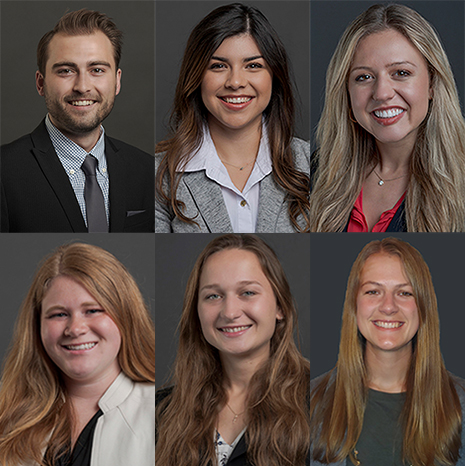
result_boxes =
[156,3,310,233]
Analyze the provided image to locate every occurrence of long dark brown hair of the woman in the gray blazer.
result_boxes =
[155,3,310,231]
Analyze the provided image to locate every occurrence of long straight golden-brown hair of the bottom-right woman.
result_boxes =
[310,238,462,466]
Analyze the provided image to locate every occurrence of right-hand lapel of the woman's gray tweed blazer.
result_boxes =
[256,174,285,233]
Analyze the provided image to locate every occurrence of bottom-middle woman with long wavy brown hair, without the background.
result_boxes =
[156,234,310,466]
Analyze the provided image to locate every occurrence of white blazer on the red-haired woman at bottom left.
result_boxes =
[20,372,155,466]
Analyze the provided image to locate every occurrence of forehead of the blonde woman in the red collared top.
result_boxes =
[353,29,426,67]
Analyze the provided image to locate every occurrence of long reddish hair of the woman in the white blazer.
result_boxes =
[0,243,155,466]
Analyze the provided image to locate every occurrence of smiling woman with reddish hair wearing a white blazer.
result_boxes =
[0,243,155,466]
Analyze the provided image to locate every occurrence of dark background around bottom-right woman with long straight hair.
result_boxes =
[310,233,465,379]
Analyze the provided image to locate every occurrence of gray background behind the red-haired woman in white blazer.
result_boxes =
[0,233,155,374]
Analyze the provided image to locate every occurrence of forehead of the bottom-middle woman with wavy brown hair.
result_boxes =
[200,249,268,286]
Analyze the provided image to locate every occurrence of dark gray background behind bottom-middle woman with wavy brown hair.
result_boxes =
[155,233,310,387]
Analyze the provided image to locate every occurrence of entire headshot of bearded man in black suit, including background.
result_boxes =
[1,1,154,232]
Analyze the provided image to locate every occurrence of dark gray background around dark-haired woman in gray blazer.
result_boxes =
[155,0,310,142]
